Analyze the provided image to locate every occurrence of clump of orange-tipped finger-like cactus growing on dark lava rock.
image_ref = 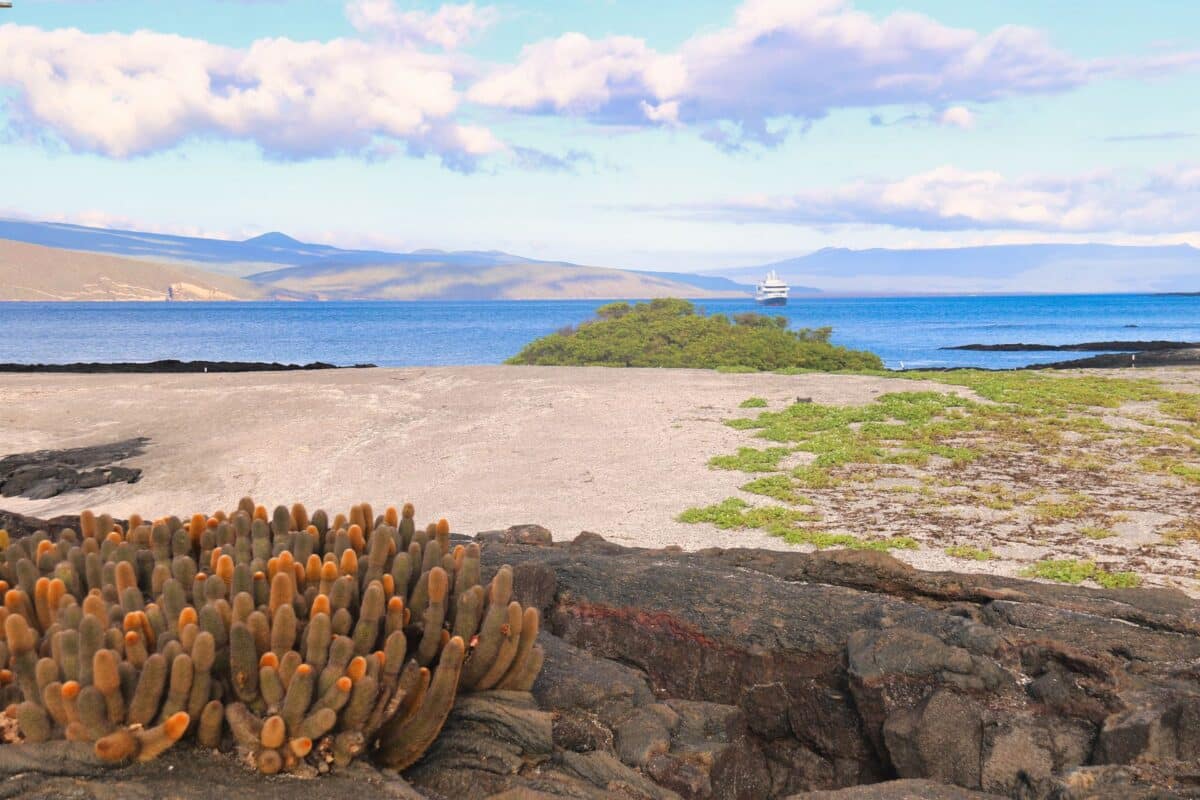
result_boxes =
[0,498,542,774]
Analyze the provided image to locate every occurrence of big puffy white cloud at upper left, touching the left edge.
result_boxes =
[0,24,504,162]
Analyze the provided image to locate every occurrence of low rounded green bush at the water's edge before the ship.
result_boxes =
[508,299,883,372]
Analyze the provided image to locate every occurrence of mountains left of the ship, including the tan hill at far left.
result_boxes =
[0,219,751,300]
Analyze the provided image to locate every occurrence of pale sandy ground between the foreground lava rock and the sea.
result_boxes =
[0,367,1200,596]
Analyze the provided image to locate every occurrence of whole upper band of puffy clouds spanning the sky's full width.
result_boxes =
[0,0,1200,165]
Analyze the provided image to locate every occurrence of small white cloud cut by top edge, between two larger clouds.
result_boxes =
[346,0,499,50]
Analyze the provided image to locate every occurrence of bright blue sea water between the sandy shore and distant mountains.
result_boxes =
[0,295,1200,368]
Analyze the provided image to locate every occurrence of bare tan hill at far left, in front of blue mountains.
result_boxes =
[0,240,287,300]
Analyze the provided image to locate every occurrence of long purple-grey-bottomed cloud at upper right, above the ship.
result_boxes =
[469,0,1196,146]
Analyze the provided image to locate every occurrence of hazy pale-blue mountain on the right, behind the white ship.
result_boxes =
[713,245,1200,294]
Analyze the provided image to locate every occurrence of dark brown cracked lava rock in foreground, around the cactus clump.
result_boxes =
[0,515,1200,800]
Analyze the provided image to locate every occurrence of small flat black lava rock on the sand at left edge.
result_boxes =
[0,438,150,500]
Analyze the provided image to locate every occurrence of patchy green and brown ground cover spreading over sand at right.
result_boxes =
[677,369,1200,590]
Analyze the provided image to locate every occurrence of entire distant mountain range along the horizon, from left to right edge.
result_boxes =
[0,219,1200,300]
